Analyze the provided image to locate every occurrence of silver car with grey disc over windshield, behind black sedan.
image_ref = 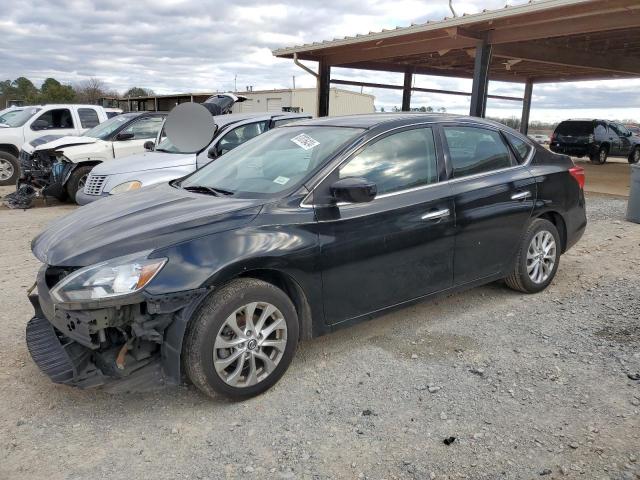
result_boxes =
[76,113,311,205]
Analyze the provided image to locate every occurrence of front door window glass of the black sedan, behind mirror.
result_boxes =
[340,128,438,195]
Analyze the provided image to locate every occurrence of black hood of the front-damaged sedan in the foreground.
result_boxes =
[31,184,264,267]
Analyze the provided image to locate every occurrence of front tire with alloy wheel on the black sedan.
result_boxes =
[182,278,299,399]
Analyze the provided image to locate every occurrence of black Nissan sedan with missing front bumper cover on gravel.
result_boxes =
[26,114,586,397]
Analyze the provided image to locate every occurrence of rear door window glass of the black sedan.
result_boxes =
[444,127,511,178]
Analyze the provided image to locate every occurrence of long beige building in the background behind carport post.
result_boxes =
[233,88,375,116]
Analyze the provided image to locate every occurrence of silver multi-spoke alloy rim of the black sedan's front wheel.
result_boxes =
[213,302,287,388]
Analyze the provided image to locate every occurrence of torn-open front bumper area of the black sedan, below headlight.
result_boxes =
[26,266,206,392]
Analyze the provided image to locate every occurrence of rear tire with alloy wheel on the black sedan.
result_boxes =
[505,218,562,293]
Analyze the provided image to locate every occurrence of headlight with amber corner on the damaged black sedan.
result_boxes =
[51,252,167,303]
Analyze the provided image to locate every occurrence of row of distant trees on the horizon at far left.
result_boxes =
[0,77,154,110]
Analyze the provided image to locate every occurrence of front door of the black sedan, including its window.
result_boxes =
[315,127,454,324]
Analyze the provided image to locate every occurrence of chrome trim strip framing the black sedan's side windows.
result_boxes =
[300,120,536,209]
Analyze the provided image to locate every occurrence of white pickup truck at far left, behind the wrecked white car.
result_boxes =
[0,105,122,185]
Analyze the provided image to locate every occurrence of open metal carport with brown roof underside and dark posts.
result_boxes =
[273,0,640,133]
